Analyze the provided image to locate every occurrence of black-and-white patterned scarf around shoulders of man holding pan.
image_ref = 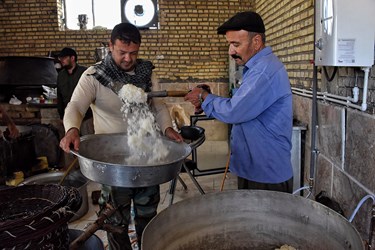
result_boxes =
[92,53,155,94]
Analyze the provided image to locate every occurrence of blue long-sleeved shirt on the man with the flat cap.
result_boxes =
[202,47,293,184]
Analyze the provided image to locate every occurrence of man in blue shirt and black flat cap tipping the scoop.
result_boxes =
[185,11,293,193]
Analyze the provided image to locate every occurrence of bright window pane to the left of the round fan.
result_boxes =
[65,0,121,30]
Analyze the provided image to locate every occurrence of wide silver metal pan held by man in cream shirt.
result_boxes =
[71,134,191,187]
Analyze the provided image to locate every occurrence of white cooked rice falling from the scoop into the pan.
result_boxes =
[118,84,168,165]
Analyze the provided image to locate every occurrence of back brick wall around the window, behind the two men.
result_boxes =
[0,0,254,82]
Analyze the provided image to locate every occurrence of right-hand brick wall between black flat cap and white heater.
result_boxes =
[255,0,314,87]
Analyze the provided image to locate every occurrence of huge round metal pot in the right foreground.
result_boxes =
[142,190,364,250]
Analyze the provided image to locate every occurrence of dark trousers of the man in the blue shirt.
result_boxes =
[238,177,293,193]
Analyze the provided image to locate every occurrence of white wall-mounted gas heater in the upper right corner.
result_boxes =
[315,0,375,67]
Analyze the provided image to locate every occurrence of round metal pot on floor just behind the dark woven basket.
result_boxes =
[20,171,89,222]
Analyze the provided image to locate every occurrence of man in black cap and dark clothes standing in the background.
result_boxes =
[57,47,94,135]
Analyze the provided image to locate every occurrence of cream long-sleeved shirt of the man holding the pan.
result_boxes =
[64,66,172,134]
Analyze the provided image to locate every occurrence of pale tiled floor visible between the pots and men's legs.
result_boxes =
[69,157,237,249]
